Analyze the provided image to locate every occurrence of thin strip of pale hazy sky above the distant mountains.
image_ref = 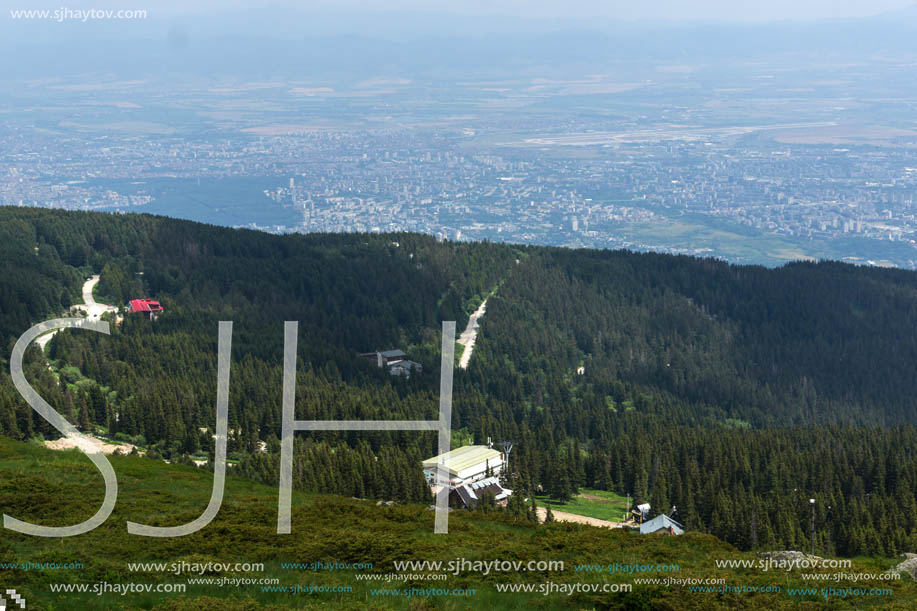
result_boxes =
[7,0,914,21]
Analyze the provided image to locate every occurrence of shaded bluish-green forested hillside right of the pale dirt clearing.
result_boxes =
[483,249,917,425]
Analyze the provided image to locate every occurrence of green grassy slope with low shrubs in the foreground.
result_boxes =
[0,439,917,611]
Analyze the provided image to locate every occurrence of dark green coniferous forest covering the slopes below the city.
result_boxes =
[0,208,917,556]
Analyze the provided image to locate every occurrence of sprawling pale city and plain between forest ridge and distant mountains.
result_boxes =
[0,77,917,268]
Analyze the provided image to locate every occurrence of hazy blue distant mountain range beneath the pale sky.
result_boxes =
[0,7,917,79]
